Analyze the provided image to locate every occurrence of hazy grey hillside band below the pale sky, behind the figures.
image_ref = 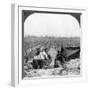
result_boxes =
[24,36,80,50]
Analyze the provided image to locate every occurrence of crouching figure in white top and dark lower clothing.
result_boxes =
[33,47,51,69]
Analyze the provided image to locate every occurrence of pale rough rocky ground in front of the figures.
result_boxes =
[24,59,80,78]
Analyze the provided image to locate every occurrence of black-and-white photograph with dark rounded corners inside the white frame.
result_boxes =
[22,10,81,79]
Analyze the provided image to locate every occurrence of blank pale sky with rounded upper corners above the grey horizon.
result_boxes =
[24,13,81,37]
